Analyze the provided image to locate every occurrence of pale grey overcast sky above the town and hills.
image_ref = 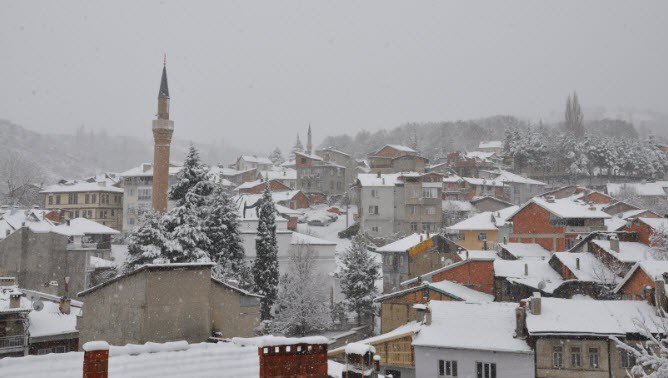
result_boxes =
[0,0,668,152]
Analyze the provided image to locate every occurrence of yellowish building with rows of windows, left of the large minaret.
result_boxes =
[40,178,123,231]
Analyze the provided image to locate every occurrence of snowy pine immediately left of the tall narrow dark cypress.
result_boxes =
[204,186,252,288]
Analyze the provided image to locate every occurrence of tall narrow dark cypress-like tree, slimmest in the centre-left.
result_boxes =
[253,181,279,320]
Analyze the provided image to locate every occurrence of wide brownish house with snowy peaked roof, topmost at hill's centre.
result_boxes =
[368,144,429,173]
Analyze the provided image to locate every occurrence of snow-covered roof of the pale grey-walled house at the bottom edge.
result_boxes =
[413,301,533,353]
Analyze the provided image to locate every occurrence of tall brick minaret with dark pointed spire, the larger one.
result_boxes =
[152,56,174,212]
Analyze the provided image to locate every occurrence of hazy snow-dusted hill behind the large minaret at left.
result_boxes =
[0,119,247,184]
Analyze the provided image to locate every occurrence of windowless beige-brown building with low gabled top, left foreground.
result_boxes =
[77,263,260,345]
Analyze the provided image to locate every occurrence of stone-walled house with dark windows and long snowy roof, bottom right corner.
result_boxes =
[516,296,663,378]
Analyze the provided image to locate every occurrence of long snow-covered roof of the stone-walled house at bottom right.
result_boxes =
[526,297,663,336]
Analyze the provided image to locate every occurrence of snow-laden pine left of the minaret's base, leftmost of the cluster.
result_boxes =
[124,210,166,271]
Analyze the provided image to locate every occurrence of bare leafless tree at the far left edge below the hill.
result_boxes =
[0,151,42,206]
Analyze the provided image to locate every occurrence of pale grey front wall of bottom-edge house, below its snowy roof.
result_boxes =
[415,346,534,378]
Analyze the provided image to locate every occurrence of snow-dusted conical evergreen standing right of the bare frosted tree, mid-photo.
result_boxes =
[340,234,380,324]
